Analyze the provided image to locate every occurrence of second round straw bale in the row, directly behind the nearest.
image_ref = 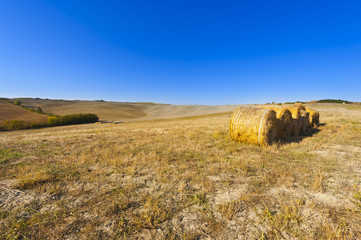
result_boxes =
[262,107,292,139]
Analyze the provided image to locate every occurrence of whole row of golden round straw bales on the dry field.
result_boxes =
[229,105,319,145]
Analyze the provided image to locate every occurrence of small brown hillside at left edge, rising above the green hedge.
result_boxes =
[0,100,48,124]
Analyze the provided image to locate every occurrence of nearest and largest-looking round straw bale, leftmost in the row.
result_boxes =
[229,108,278,146]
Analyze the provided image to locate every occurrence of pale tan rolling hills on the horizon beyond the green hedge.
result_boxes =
[4,98,243,121]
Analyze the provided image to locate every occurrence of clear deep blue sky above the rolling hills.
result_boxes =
[0,0,361,104]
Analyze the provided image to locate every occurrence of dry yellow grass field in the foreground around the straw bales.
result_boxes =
[0,104,361,239]
